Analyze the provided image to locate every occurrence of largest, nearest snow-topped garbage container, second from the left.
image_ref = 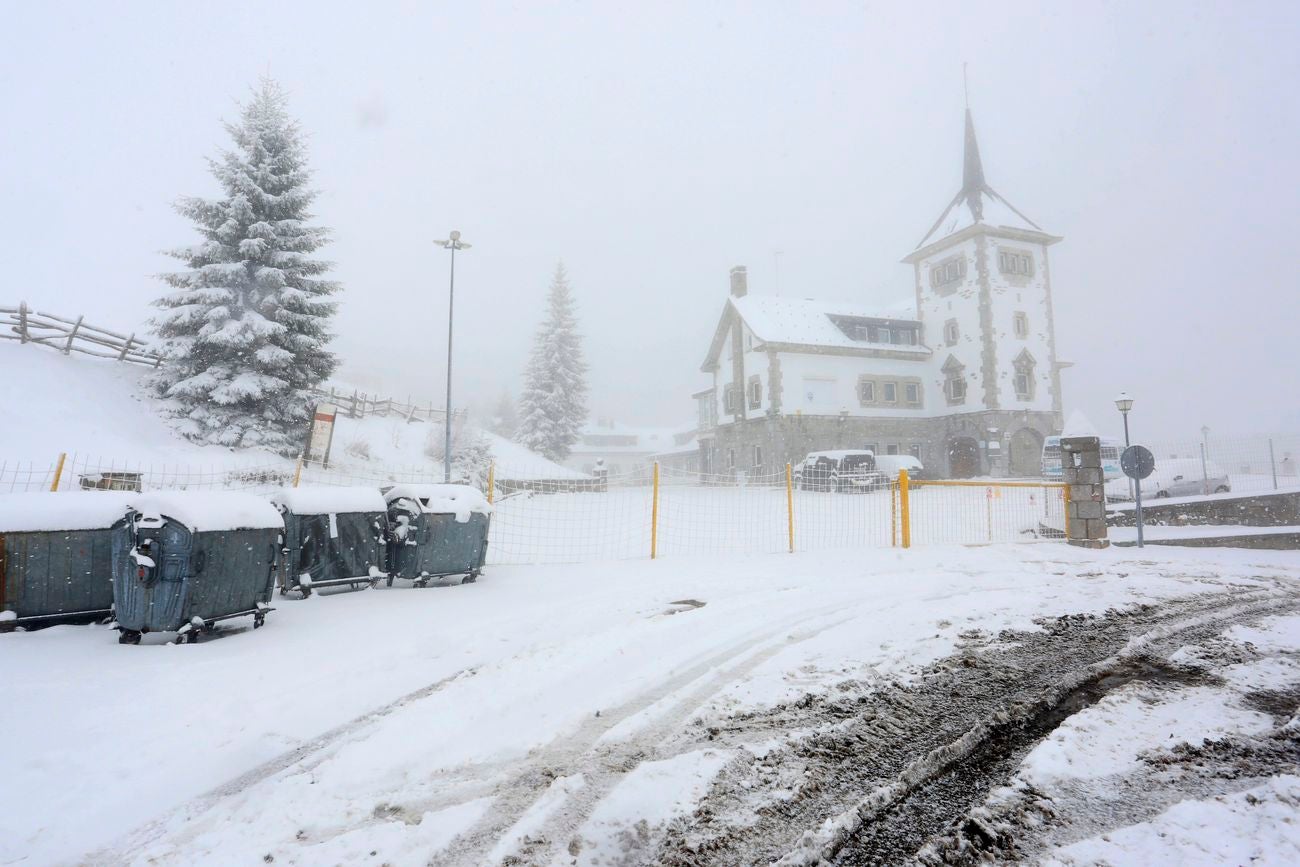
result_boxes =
[113,491,285,645]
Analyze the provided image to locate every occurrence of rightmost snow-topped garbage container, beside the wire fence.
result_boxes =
[384,485,491,588]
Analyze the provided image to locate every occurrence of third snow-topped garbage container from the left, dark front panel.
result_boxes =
[270,486,389,599]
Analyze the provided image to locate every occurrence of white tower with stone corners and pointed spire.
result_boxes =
[904,108,1062,476]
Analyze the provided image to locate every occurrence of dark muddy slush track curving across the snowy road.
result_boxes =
[645,589,1300,867]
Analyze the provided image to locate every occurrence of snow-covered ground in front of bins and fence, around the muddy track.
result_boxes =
[0,543,1300,866]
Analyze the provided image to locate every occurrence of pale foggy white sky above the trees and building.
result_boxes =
[0,3,1300,438]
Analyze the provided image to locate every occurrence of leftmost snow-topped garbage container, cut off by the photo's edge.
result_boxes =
[0,491,129,629]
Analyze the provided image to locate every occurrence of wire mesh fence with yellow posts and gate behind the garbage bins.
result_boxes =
[0,455,1065,564]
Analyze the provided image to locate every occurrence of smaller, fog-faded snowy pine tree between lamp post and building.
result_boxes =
[515,263,586,460]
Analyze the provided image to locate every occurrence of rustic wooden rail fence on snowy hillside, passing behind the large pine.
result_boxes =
[0,302,464,422]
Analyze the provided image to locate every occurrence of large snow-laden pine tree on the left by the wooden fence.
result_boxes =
[152,78,339,455]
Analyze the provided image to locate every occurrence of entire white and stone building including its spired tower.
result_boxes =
[696,109,1067,478]
